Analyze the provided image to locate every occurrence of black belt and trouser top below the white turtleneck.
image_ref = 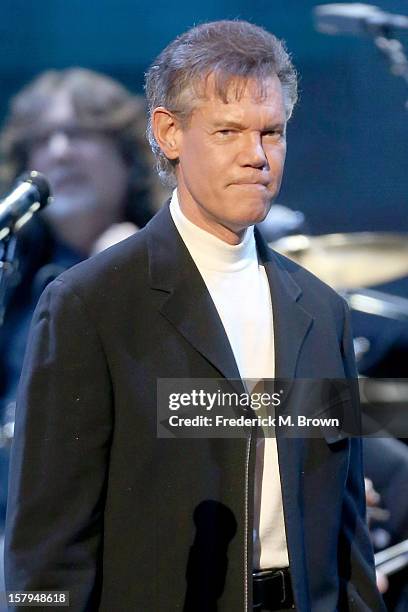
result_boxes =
[253,567,294,610]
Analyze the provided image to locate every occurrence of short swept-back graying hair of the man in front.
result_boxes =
[145,20,297,186]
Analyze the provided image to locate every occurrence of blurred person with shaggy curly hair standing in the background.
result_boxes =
[0,68,157,604]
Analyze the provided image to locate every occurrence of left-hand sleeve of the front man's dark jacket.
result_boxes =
[5,279,113,612]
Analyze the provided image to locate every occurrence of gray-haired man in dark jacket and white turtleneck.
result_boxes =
[6,21,384,612]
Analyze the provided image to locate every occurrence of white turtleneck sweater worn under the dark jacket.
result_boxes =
[170,190,289,569]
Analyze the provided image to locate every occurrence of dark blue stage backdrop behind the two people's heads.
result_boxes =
[0,0,408,234]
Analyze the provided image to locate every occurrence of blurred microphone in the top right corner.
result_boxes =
[313,3,408,35]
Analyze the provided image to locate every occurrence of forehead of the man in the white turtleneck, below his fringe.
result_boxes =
[192,75,286,123]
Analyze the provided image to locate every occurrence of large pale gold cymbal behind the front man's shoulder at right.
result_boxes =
[269,232,408,289]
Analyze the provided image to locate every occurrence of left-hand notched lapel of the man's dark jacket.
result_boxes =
[146,205,243,392]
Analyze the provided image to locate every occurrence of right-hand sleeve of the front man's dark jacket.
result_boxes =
[338,304,386,612]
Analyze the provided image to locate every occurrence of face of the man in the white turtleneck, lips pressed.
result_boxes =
[176,77,286,243]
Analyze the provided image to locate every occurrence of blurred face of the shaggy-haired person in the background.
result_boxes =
[27,91,129,230]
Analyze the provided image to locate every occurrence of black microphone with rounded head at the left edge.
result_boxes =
[0,170,50,240]
